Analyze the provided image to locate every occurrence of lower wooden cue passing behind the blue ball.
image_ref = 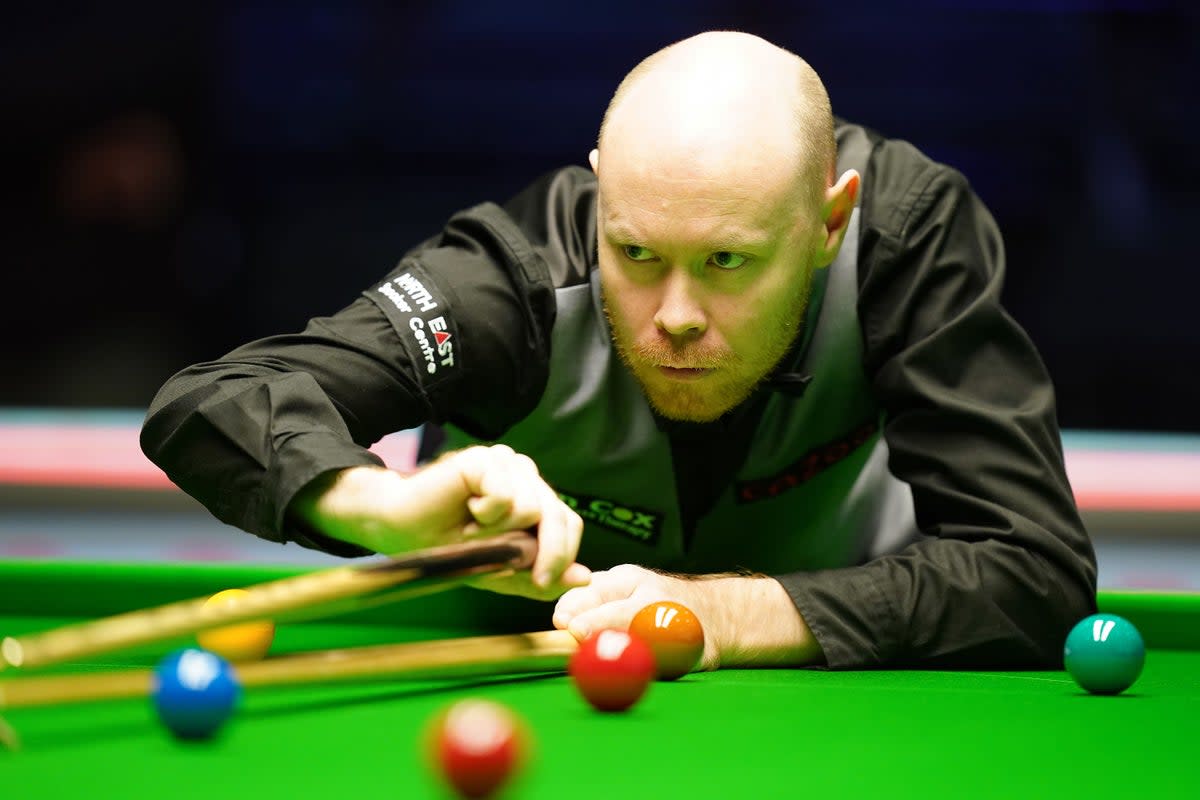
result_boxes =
[0,631,578,709]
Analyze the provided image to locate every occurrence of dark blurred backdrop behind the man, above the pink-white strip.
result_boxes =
[0,0,1200,431]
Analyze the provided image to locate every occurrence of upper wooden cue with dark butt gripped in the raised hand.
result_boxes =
[0,533,538,672]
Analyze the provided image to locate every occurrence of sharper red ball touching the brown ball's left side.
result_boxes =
[566,630,654,711]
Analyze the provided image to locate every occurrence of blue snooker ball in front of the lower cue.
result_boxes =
[151,648,241,739]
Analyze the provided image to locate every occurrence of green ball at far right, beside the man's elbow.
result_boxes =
[1062,614,1146,694]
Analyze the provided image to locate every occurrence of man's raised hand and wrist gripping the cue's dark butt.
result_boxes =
[293,445,590,600]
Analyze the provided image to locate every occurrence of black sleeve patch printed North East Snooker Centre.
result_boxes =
[364,263,460,389]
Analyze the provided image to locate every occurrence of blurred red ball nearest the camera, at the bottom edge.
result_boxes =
[434,699,523,798]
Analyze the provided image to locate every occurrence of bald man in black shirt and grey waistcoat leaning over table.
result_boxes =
[143,32,1096,668]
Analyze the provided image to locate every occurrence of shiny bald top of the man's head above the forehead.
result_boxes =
[598,31,834,211]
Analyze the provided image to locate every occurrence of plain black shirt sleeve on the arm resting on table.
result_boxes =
[781,142,1096,668]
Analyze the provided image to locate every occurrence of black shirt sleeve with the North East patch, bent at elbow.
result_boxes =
[142,196,554,555]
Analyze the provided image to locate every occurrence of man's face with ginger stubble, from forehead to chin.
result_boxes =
[598,151,820,422]
